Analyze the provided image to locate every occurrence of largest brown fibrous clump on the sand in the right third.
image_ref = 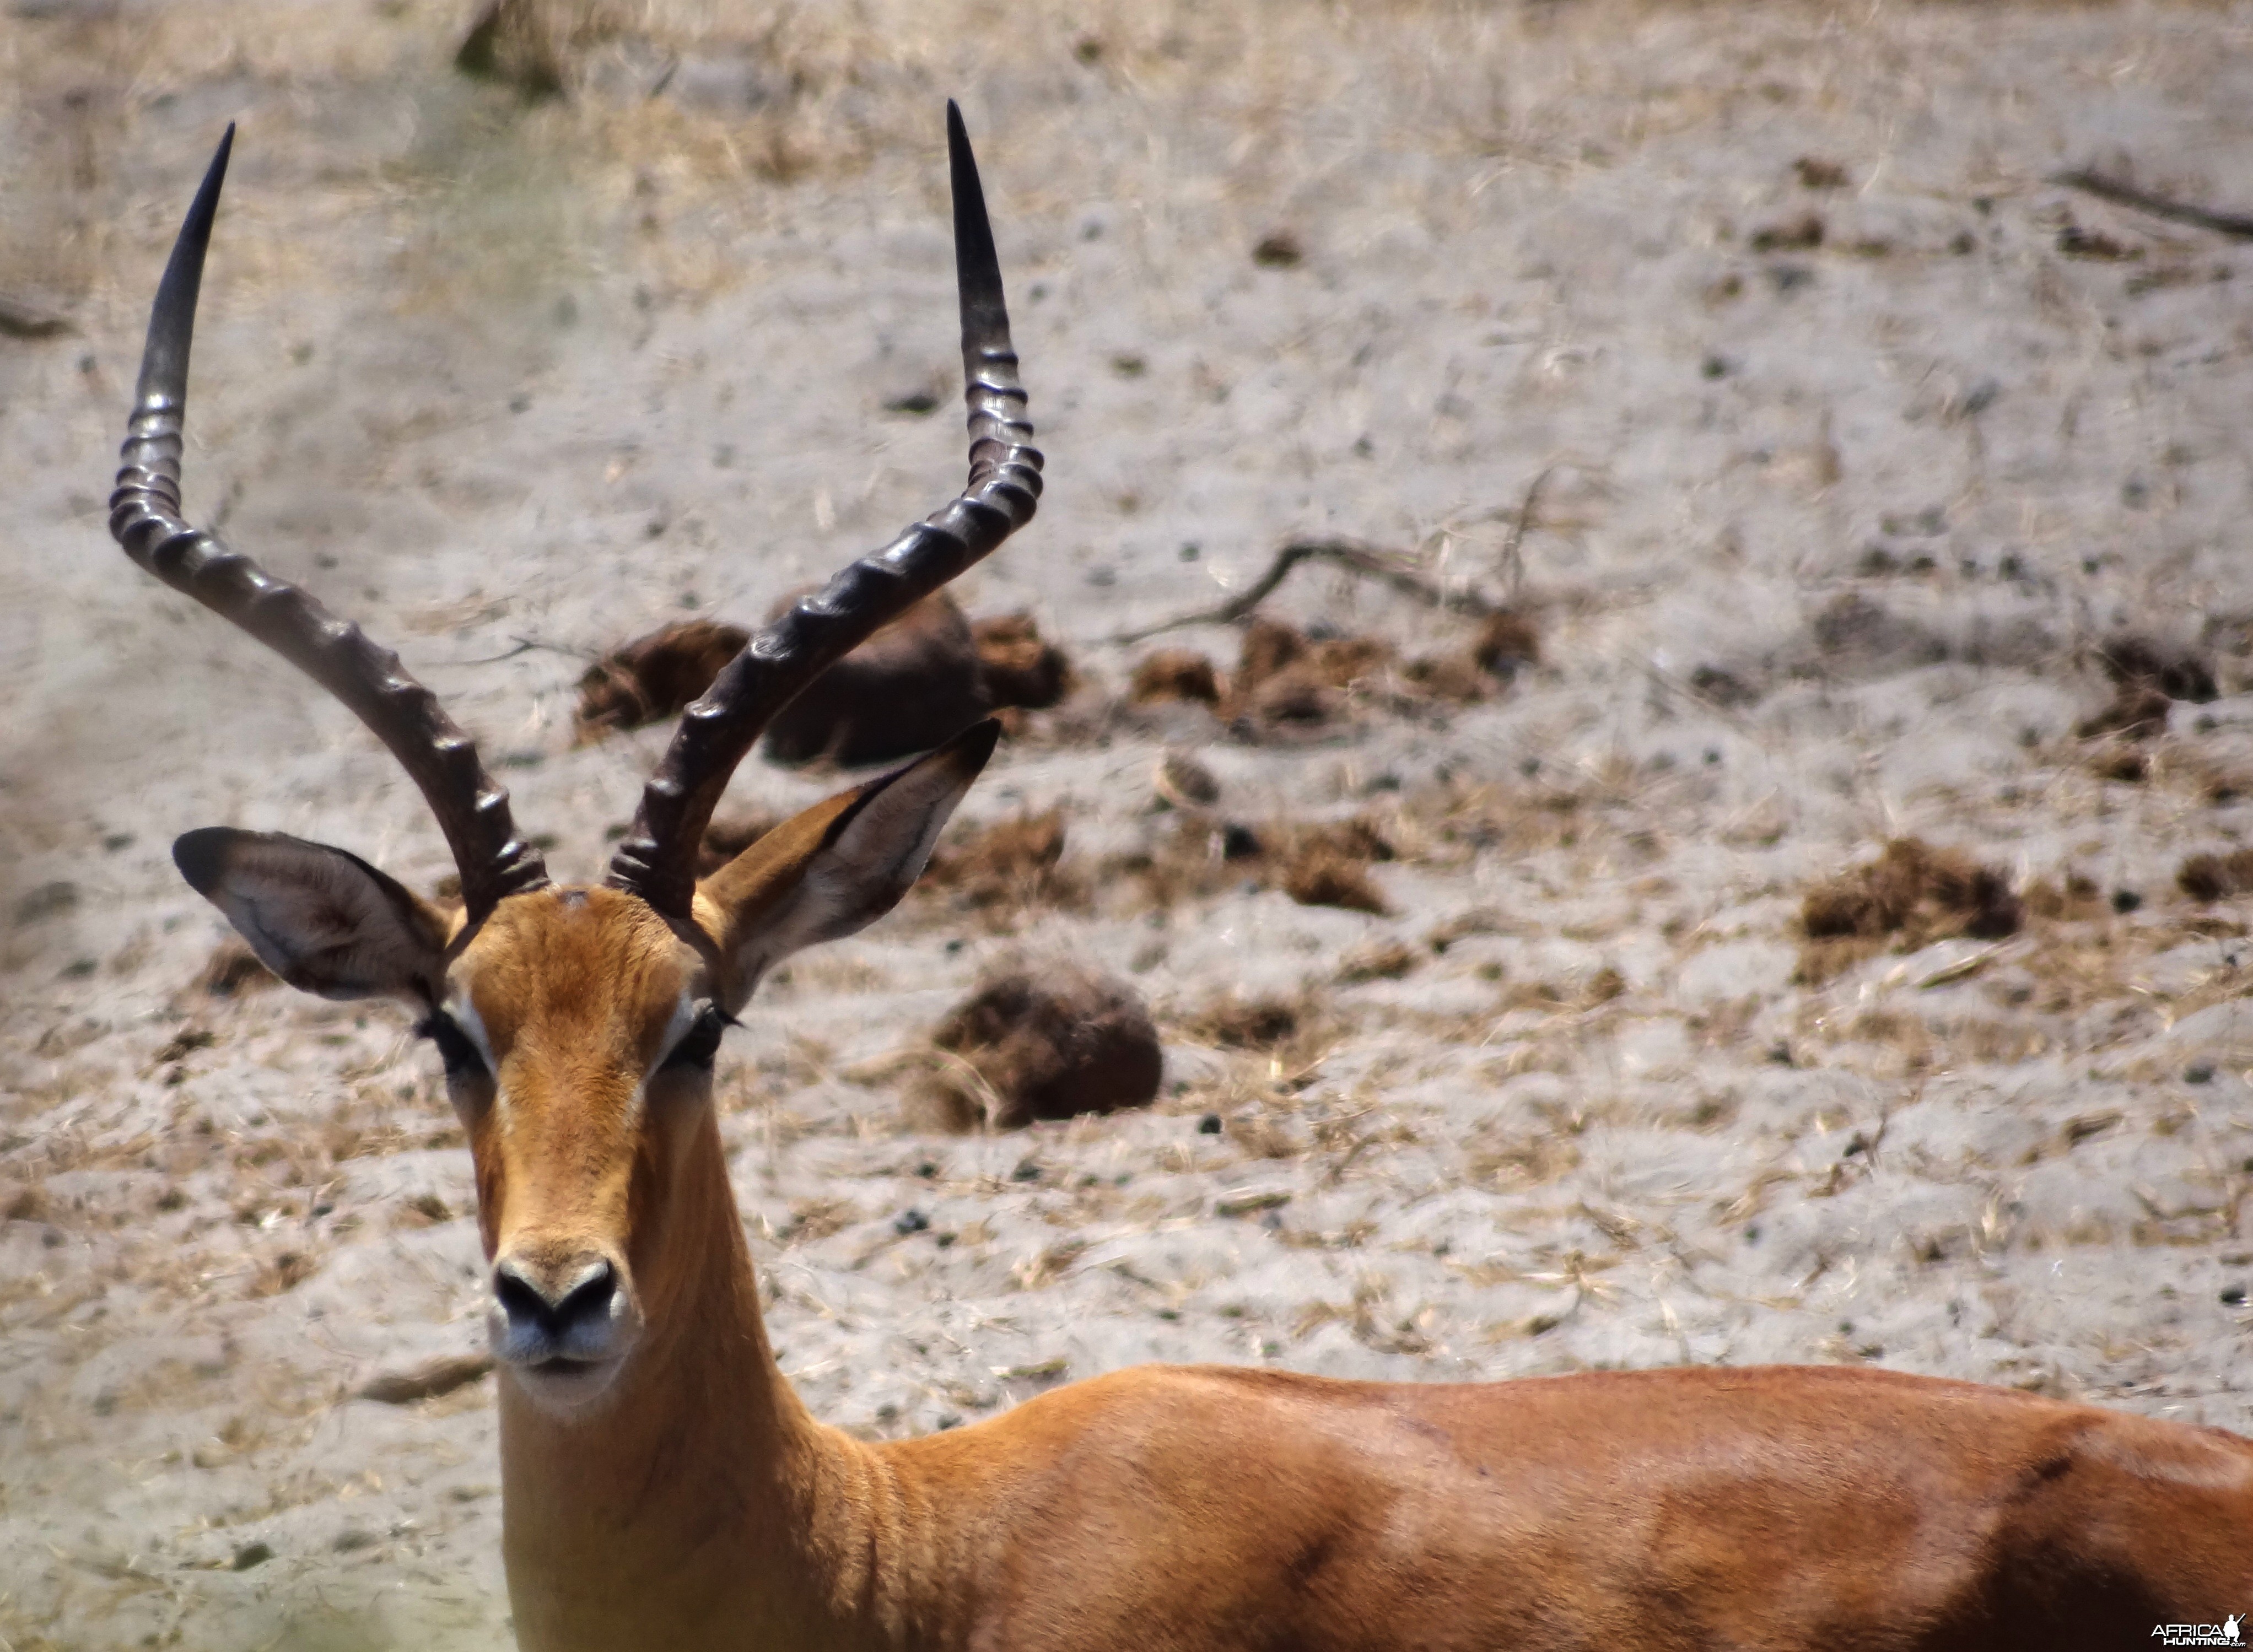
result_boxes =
[1798,838,2023,985]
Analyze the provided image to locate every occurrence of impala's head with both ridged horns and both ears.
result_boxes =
[110,104,1041,1413]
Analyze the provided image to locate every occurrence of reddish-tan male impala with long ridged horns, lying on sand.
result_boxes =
[110,106,2253,1652]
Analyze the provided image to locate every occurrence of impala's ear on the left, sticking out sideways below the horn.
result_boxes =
[171,827,453,1005]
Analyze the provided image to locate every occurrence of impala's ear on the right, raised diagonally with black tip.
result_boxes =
[696,719,1000,1014]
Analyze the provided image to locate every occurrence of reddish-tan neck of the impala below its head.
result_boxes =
[500,1120,890,1652]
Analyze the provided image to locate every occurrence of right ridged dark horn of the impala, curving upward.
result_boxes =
[606,99,1041,917]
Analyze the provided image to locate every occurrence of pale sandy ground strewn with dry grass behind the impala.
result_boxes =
[0,0,2253,1652]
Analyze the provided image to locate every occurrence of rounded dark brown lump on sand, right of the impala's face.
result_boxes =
[908,960,1165,1129]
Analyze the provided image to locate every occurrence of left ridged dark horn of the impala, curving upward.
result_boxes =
[110,124,552,924]
